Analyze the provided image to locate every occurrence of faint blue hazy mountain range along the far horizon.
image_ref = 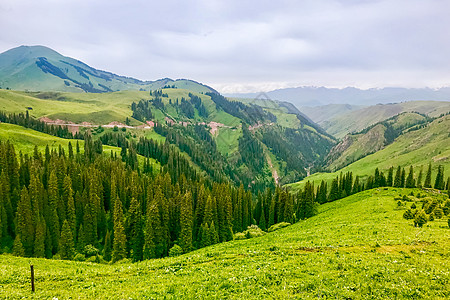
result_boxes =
[225,86,450,107]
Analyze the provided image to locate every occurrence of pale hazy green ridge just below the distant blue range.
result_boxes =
[301,101,450,138]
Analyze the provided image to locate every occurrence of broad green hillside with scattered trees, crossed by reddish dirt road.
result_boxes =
[0,87,335,188]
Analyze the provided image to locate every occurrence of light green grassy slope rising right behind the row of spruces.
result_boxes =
[288,115,450,190]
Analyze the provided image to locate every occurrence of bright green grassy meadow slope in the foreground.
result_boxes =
[0,188,450,299]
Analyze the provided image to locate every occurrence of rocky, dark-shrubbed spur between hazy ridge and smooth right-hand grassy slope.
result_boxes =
[325,113,429,171]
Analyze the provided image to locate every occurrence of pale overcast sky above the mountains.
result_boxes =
[0,0,450,93]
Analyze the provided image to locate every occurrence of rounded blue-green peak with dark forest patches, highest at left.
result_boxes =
[0,46,216,93]
